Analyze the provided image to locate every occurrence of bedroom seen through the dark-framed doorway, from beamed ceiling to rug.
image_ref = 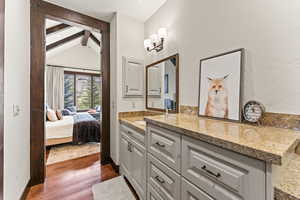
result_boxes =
[45,18,102,166]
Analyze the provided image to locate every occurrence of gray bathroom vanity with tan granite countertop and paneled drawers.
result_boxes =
[120,114,299,200]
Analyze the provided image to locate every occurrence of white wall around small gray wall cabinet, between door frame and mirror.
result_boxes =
[111,13,145,164]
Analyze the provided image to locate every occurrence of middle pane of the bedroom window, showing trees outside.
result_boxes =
[76,75,92,110]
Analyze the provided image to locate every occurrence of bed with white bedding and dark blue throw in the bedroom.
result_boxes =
[46,113,101,146]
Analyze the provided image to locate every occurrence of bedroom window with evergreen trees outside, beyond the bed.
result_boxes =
[64,73,102,110]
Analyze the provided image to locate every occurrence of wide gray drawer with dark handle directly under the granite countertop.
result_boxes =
[182,136,265,200]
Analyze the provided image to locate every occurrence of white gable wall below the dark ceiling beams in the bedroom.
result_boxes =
[46,44,100,70]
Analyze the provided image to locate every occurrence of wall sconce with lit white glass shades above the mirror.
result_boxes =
[144,28,168,52]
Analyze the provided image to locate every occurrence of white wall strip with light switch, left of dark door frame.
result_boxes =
[4,0,30,200]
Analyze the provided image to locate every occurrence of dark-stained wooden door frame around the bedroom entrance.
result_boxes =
[30,0,111,185]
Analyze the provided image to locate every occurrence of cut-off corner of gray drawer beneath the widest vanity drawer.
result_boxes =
[181,178,216,200]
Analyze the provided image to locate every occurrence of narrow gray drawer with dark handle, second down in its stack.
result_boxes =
[147,154,180,200]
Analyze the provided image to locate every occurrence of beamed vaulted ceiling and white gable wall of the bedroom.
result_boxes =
[45,19,101,70]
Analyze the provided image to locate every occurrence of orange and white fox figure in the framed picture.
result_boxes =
[205,75,229,119]
